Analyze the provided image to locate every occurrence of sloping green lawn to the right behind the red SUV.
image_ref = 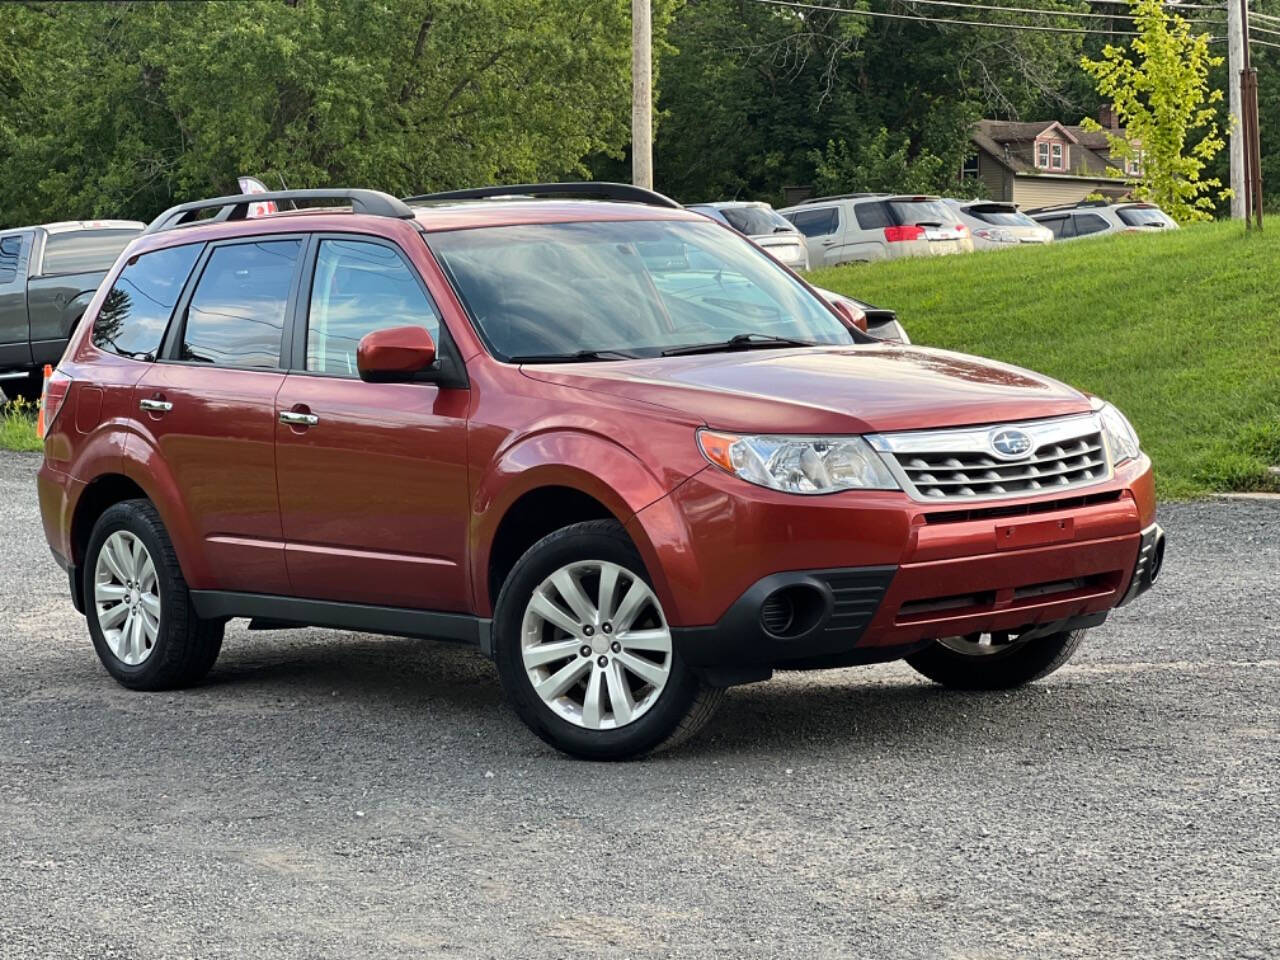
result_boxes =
[810,223,1280,499]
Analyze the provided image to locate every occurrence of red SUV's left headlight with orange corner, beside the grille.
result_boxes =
[698,430,899,494]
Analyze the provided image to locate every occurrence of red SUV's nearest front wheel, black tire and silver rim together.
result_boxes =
[493,521,723,760]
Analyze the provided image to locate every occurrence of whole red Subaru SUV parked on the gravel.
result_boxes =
[38,184,1164,759]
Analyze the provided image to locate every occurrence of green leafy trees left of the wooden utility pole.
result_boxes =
[0,0,640,224]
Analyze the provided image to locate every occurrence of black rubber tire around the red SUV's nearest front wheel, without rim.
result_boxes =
[493,520,724,760]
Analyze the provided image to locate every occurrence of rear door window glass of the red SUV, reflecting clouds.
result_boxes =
[178,239,302,369]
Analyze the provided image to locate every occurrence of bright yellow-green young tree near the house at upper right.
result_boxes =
[1080,0,1228,223]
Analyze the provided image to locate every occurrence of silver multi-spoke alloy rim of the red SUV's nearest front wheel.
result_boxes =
[521,561,672,730]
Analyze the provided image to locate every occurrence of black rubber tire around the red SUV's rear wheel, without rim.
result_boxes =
[81,500,225,690]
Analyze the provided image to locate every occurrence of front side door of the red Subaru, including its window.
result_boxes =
[275,236,470,611]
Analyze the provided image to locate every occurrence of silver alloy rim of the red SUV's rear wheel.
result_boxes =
[93,530,160,667]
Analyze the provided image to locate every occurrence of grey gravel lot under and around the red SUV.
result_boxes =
[0,453,1280,960]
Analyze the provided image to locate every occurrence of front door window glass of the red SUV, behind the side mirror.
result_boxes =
[307,239,440,376]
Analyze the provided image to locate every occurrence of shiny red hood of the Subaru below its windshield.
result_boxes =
[524,344,1089,434]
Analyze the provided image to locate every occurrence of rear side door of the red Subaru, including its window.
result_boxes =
[133,236,305,594]
